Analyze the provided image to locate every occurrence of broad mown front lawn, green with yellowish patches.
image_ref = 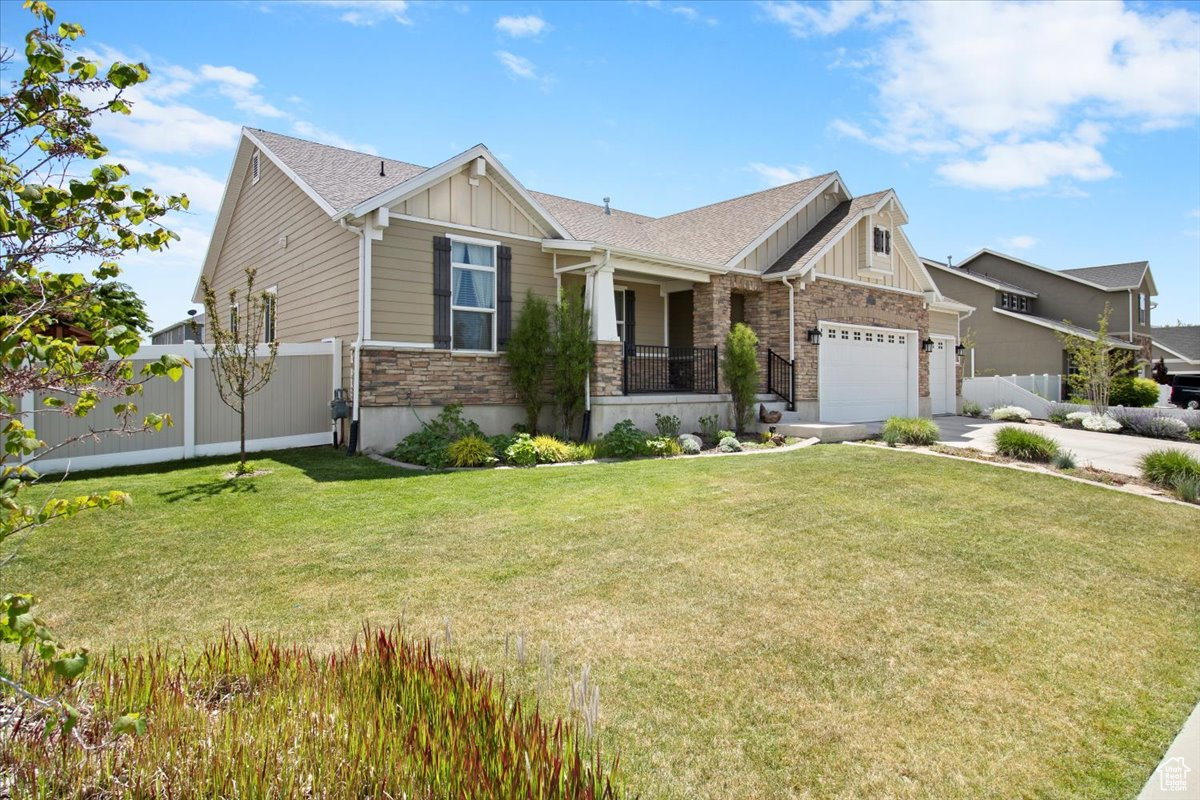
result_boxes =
[4,446,1200,798]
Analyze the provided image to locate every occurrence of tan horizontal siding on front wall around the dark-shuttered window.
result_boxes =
[371,219,554,344]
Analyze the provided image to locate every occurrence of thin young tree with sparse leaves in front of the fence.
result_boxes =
[200,267,280,475]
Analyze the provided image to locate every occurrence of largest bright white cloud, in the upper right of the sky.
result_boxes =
[787,1,1200,191]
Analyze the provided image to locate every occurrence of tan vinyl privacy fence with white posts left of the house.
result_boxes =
[22,339,341,473]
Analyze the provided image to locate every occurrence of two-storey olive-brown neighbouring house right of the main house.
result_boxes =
[922,249,1157,388]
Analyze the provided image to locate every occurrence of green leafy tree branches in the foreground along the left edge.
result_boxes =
[0,1,187,729]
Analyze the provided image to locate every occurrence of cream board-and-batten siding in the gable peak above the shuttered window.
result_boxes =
[392,172,550,239]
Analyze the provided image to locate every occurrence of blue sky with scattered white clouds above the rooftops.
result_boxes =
[7,0,1200,325]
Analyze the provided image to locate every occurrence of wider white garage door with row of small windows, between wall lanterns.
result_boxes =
[817,323,917,422]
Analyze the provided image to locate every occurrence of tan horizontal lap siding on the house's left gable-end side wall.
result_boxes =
[208,156,359,393]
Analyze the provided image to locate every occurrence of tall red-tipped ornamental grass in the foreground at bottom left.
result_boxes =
[0,628,623,800]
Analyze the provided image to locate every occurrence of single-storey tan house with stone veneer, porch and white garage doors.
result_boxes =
[189,128,970,450]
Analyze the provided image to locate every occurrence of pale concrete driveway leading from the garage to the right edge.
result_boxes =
[934,416,1200,476]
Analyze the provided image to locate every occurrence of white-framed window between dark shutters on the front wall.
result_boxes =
[450,239,496,351]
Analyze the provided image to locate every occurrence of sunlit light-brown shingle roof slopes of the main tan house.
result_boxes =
[247,128,844,265]
